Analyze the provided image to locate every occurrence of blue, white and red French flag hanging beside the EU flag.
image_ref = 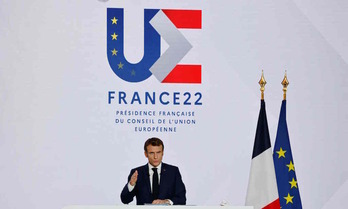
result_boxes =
[245,100,280,209]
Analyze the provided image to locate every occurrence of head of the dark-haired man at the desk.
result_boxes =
[144,137,164,167]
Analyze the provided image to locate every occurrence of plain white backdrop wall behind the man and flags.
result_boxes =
[0,0,348,209]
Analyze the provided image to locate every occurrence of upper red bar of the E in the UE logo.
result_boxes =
[162,9,202,29]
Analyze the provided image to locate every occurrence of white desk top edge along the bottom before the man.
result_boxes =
[62,205,254,209]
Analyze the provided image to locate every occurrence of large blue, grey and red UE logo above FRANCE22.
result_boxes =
[107,8,202,83]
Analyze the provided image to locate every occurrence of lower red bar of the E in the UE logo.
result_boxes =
[162,65,202,83]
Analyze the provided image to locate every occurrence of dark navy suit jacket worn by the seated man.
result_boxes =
[121,162,186,205]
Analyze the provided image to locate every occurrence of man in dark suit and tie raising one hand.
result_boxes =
[121,138,186,205]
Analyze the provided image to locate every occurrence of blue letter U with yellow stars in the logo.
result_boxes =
[106,8,161,82]
